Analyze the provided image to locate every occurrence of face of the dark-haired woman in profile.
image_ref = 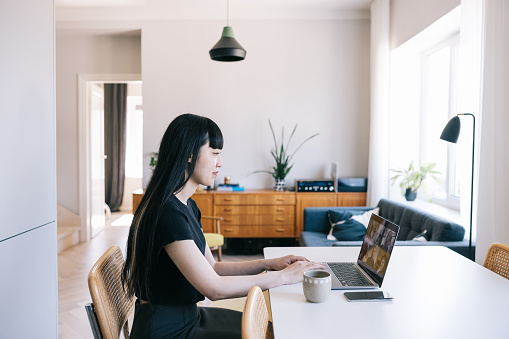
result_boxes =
[189,142,223,186]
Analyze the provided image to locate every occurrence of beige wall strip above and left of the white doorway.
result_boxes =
[56,31,141,214]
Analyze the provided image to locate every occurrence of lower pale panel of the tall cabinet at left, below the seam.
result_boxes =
[0,222,57,339]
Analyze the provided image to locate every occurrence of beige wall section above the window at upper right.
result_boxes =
[391,0,461,49]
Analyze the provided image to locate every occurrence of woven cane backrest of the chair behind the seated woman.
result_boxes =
[88,245,134,339]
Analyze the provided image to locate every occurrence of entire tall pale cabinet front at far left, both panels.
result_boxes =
[0,0,58,338]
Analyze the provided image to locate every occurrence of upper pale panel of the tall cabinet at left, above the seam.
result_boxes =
[0,0,56,240]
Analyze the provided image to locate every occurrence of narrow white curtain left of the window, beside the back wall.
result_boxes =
[367,0,390,206]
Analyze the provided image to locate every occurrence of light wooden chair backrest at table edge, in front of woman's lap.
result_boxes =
[242,286,274,339]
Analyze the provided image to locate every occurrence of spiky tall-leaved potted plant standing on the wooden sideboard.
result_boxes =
[253,120,319,191]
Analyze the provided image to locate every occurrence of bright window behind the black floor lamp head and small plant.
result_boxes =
[420,34,460,209]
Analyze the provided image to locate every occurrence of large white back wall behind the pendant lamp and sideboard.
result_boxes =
[142,19,370,188]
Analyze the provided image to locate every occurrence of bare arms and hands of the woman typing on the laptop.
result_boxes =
[164,240,323,300]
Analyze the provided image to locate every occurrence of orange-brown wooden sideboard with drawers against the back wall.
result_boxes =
[133,190,366,239]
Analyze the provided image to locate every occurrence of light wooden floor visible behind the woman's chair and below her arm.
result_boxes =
[58,213,262,339]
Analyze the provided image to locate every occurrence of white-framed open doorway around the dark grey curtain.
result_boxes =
[78,74,143,242]
